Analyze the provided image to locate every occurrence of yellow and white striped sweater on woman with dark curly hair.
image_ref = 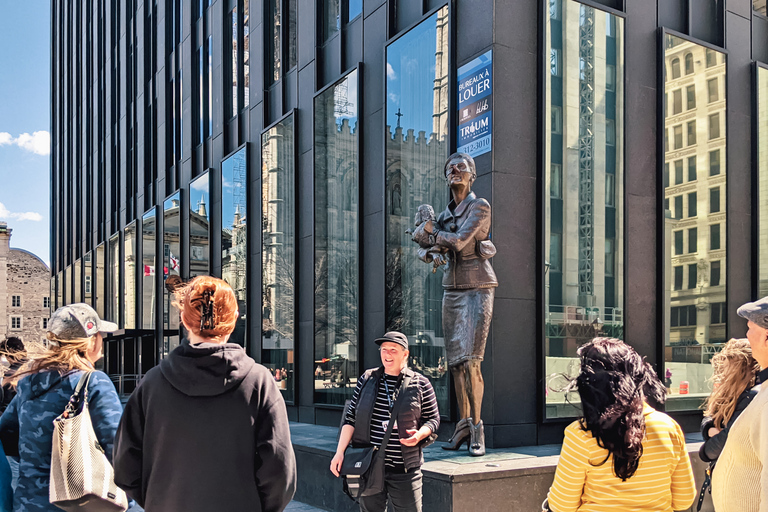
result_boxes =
[548,404,696,512]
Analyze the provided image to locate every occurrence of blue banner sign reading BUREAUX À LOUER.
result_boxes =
[456,50,493,158]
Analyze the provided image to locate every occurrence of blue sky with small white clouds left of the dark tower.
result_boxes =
[0,0,51,263]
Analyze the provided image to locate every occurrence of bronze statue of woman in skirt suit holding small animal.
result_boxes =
[413,153,498,456]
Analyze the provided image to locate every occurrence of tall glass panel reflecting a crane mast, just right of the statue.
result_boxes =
[543,0,624,418]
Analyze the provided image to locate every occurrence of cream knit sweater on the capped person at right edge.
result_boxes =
[712,386,768,512]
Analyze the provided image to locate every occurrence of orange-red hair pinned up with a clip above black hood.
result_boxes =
[173,276,238,340]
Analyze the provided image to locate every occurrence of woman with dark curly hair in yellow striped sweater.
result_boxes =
[542,338,696,512]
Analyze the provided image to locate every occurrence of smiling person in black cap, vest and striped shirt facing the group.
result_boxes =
[331,331,440,512]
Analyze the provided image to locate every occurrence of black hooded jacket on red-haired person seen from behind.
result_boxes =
[114,341,296,512]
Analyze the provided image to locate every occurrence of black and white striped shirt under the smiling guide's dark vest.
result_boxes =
[344,373,440,469]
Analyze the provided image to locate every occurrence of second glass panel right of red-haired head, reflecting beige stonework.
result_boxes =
[261,116,296,401]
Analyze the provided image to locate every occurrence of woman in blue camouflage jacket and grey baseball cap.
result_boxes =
[0,304,122,512]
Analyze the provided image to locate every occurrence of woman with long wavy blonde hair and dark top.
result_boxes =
[699,338,760,462]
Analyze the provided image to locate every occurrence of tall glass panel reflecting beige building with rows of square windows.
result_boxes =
[660,34,727,411]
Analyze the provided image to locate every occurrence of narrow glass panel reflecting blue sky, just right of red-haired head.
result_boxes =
[221,148,248,347]
